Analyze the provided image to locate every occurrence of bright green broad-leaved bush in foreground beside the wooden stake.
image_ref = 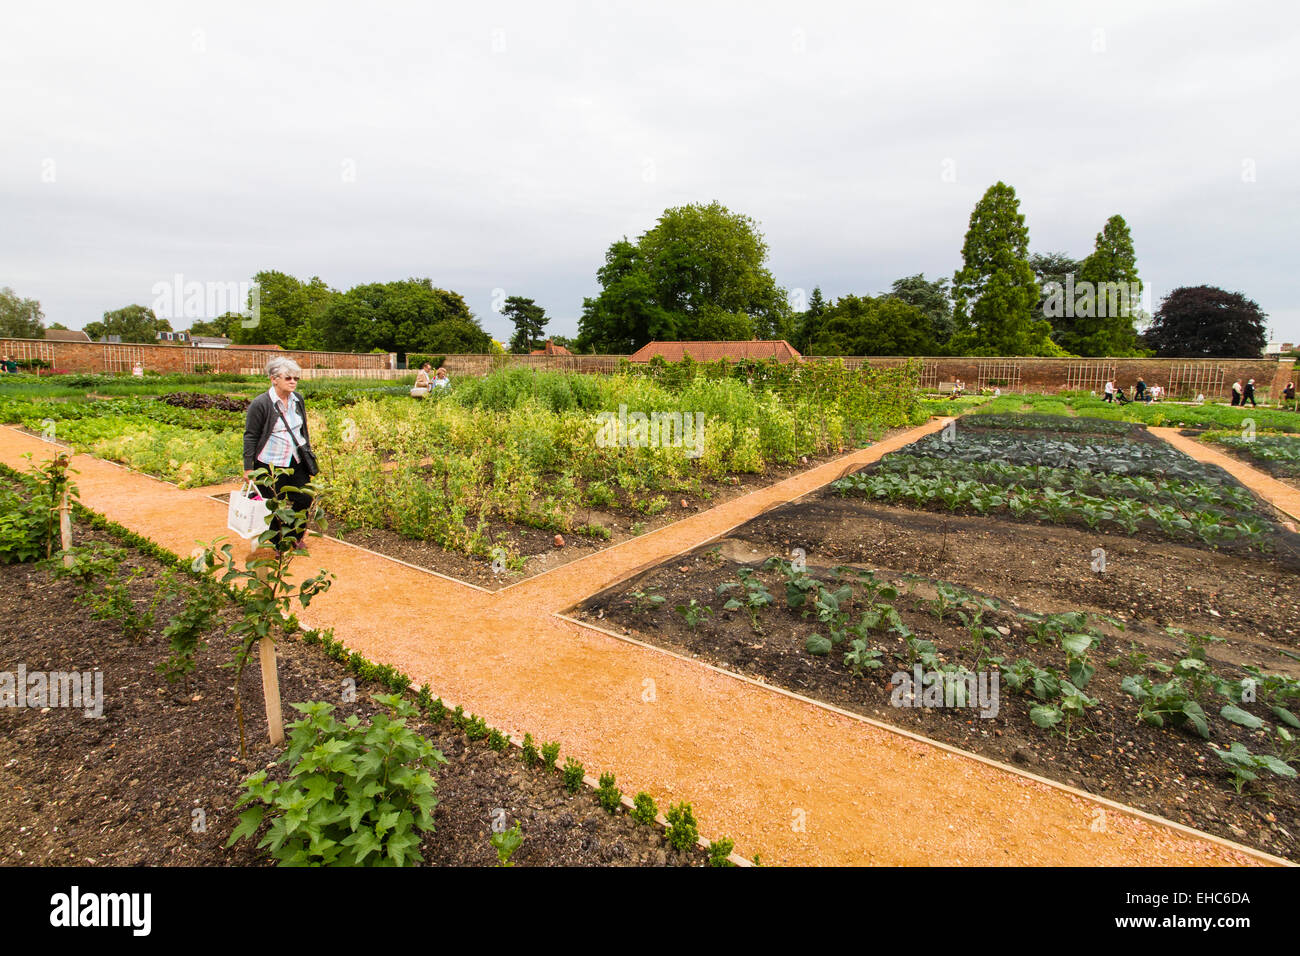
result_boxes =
[226,695,446,866]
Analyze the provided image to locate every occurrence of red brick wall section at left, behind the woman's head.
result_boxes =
[0,338,389,373]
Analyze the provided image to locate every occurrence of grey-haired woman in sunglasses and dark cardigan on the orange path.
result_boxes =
[243,358,316,550]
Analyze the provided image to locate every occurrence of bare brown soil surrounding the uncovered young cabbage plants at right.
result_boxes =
[575,489,1300,861]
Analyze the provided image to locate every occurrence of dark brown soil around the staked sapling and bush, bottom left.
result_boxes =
[0,531,706,866]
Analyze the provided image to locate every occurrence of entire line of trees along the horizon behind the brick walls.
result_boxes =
[0,182,1268,358]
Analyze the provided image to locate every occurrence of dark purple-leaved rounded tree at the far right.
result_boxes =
[1143,285,1268,359]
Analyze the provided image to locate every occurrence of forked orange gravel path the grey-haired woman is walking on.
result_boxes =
[0,421,1283,866]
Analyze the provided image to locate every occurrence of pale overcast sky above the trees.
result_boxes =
[0,0,1300,342]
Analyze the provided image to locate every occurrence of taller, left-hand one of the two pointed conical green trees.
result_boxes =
[949,182,1062,355]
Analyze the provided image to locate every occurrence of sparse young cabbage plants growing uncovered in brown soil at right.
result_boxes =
[686,558,1300,792]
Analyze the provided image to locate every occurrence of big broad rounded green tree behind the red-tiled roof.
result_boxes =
[579,202,794,351]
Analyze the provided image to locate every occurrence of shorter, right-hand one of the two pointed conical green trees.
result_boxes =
[1049,216,1141,355]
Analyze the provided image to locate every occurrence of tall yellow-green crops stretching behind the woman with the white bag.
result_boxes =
[0,365,924,559]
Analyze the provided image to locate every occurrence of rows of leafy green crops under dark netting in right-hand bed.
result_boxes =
[833,415,1277,549]
